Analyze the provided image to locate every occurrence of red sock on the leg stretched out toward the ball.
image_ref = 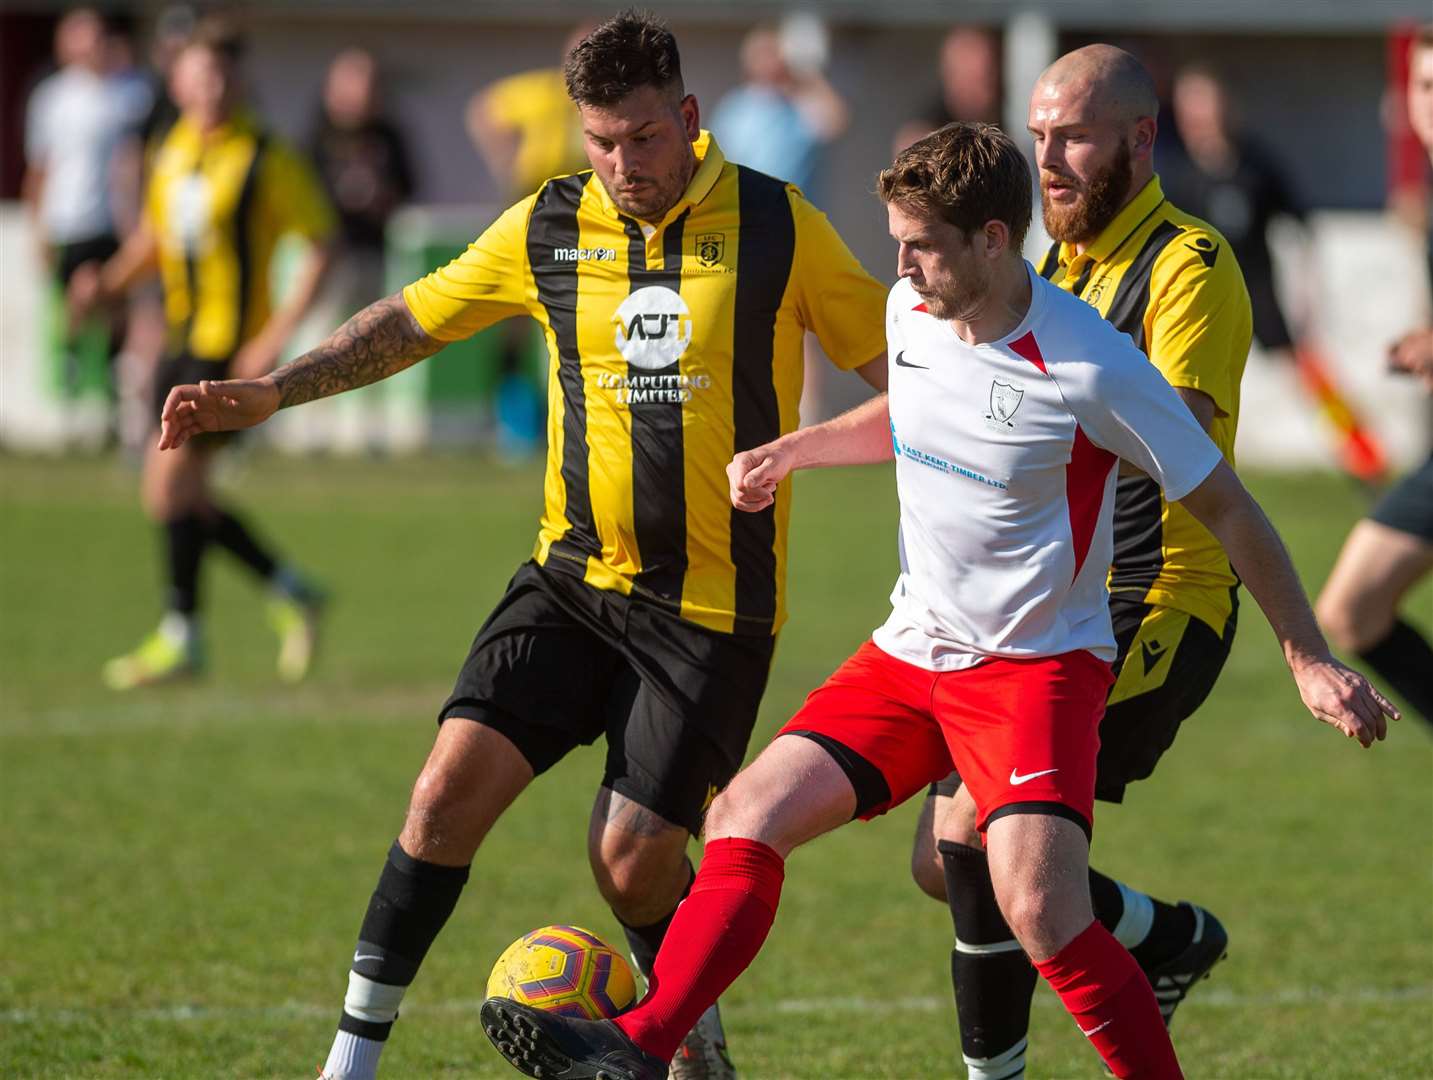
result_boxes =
[616,839,785,1061]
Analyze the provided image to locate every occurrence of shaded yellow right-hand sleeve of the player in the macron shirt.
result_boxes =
[787,186,890,371]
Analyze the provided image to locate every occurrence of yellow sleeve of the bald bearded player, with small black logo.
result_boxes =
[1145,228,1254,415]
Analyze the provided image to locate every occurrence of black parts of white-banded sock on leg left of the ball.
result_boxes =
[338,841,469,1043]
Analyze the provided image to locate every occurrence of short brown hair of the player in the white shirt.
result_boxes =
[876,120,1032,251]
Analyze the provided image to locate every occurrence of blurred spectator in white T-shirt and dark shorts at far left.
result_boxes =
[21,9,149,437]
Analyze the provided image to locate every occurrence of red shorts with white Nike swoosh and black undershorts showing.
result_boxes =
[780,642,1113,834]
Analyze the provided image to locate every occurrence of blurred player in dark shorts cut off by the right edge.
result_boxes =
[1318,26,1433,723]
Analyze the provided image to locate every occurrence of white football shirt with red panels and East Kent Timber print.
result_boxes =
[874,264,1221,670]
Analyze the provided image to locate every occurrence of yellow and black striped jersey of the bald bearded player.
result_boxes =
[1040,178,1252,636]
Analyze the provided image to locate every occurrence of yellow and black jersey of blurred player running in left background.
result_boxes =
[145,112,334,361]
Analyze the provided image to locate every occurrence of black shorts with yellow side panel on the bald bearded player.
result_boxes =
[929,597,1238,802]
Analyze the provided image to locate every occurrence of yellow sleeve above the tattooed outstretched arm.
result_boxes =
[403,195,537,341]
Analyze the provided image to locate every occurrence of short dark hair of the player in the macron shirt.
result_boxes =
[563,9,684,107]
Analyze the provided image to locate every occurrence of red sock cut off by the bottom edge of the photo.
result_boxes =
[1035,921,1184,1080]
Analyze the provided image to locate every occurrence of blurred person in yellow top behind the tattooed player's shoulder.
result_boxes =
[464,23,592,458]
